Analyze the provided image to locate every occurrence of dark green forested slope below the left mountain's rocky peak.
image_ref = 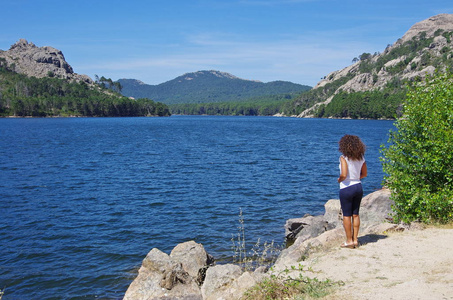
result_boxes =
[0,58,170,117]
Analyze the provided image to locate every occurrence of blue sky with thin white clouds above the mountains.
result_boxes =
[0,0,453,86]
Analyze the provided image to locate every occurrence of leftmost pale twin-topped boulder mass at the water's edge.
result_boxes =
[124,241,213,300]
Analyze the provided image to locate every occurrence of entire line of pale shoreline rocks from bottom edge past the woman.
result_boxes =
[124,189,405,300]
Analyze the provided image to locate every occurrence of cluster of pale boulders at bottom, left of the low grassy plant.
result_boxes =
[124,241,266,300]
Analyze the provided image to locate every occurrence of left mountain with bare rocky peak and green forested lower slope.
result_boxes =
[0,39,170,117]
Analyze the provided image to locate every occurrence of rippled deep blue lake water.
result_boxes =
[0,116,393,300]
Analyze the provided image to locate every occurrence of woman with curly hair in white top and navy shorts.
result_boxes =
[338,135,368,248]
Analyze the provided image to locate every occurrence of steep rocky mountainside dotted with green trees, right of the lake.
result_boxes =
[283,14,453,118]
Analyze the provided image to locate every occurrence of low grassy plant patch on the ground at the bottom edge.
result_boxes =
[242,265,344,300]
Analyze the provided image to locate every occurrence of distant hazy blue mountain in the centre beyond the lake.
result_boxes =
[118,70,311,104]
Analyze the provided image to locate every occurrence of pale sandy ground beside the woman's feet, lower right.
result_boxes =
[302,228,453,300]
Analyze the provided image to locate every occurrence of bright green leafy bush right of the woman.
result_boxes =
[381,72,453,223]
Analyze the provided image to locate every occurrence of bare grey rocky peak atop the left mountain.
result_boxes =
[0,39,93,84]
